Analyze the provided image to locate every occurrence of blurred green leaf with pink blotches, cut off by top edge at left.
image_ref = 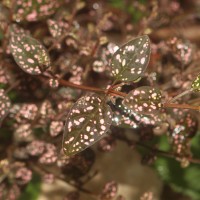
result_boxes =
[13,0,60,22]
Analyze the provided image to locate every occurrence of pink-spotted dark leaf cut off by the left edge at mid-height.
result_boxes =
[0,89,11,121]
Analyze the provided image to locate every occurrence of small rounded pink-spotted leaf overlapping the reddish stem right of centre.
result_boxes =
[123,86,162,114]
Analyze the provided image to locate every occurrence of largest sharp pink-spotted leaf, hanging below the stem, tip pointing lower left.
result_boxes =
[63,94,112,156]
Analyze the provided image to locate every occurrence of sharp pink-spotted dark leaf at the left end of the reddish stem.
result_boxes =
[10,34,50,75]
